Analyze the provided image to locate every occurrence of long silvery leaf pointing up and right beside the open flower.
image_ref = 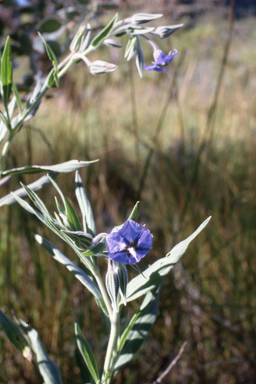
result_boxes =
[127,217,211,302]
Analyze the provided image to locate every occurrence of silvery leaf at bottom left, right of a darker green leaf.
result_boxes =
[18,319,62,384]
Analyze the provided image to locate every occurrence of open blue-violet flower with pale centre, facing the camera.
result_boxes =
[106,220,152,264]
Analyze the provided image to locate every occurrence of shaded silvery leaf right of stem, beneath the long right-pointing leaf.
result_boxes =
[114,287,160,373]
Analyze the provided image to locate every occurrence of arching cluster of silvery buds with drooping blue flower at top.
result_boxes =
[70,13,182,77]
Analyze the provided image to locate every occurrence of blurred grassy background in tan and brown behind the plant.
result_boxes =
[0,0,256,384]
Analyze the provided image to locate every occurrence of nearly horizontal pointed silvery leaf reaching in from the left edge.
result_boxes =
[2,160,98,177]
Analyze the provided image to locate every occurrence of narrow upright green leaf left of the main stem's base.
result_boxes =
[72,311,100,383]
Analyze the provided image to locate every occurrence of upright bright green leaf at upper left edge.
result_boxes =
[1,36,12,110]
